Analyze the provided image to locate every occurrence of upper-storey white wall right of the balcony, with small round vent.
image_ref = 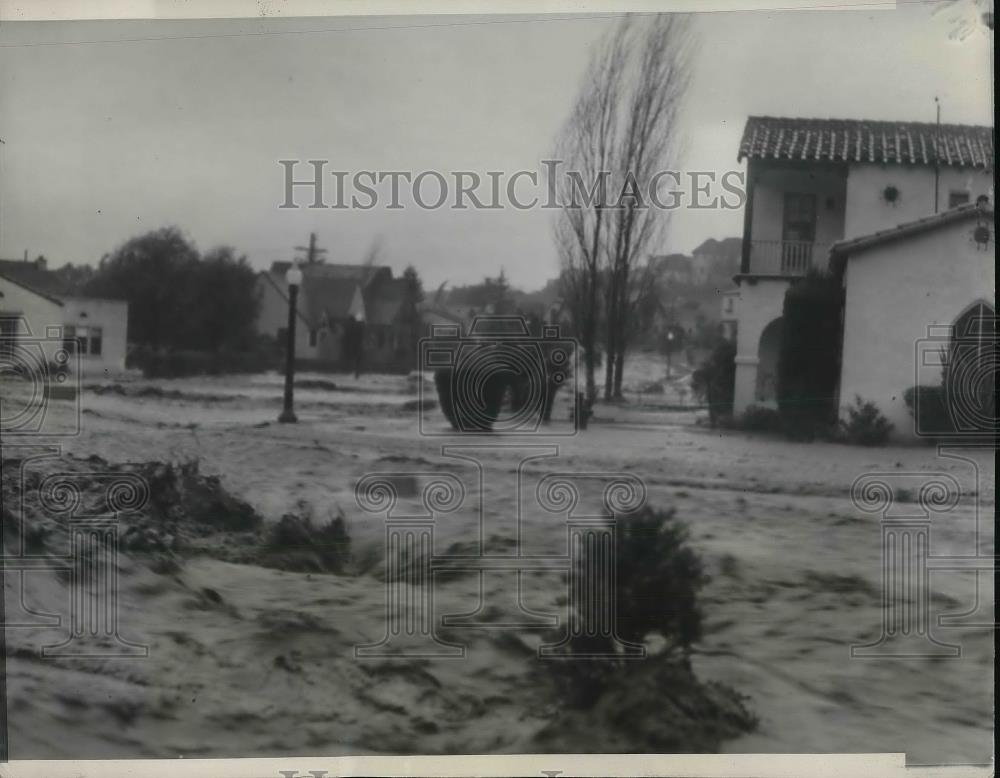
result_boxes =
[844,164,993,238]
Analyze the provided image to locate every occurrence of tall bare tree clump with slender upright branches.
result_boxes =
[553,14,691,399]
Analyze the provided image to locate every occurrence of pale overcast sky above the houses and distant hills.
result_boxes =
[0,4,992,289]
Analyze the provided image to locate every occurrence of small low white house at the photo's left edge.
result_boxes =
[0,257,128,376]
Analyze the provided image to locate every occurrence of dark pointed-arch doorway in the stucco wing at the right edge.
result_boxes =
[942,301,1000,434]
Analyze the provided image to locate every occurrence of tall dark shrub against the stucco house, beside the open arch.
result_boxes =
[777,271,844,438]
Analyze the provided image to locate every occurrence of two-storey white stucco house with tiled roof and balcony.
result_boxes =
[734,116,995,434]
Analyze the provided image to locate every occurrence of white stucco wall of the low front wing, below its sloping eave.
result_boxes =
[840,215,996,439]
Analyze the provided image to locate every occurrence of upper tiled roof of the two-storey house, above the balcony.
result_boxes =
[737,116,993,170]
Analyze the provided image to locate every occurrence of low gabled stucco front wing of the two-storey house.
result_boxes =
[831,205,997,439]
